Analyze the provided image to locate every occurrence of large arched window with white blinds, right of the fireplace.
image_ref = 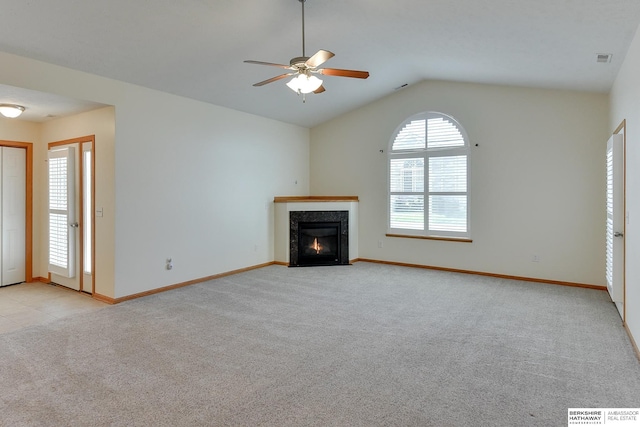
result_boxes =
[388,112,470,240]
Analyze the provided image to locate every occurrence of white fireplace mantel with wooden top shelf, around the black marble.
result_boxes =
[273,196,358,265]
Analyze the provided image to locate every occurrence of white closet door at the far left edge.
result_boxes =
[0,147,27,286]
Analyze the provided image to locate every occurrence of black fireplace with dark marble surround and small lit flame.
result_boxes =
[289,211,349,267]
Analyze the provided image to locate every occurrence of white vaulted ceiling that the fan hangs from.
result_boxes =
[0,0,640,127]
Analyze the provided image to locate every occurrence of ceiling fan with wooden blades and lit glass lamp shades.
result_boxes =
[244,0,369,98]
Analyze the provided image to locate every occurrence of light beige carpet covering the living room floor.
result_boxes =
[0,262,640,426]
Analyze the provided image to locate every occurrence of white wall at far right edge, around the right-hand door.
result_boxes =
[609,22,640,352]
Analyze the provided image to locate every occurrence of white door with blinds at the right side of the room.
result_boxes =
[606,134,624,320]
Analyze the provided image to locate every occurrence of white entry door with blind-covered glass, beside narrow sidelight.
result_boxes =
[48,146,80,291]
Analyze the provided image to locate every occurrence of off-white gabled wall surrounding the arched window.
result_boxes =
[311,82,609,285]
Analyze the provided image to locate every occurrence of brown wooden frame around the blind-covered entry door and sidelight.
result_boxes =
[47,135,96,295]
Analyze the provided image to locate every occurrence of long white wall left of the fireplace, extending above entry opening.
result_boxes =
[0,53,309,298]
